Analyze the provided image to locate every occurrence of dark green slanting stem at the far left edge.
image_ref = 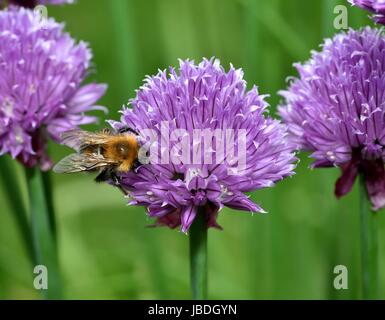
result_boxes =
[0,156,36,264]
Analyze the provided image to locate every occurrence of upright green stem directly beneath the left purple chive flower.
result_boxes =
[26,167,61,299]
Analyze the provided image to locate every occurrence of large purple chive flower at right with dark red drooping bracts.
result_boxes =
[279,27,385,210]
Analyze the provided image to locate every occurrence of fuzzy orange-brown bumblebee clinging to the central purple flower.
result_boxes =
[53,129,140,194]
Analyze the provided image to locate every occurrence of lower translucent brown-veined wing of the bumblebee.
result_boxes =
[53,153,116,173]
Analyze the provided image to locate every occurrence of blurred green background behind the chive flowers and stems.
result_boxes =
[0,0,385,299]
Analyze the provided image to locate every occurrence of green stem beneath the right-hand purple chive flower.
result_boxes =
[360,174,378,300]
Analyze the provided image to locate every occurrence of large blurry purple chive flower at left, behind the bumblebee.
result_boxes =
[0,8,106,170]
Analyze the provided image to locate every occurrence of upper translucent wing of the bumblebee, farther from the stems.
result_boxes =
[61,129,109,152]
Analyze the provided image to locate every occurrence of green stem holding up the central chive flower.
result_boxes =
[189,208,207,300]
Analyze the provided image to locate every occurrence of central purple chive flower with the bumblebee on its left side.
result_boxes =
[111,59,295,232]
